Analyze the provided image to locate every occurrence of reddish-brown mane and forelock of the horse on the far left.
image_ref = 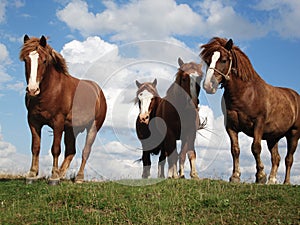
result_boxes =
[19,37,70,76]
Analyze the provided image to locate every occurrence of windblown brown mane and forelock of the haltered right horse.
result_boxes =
[200,37,261,81]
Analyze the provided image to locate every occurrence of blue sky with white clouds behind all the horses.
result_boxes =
[0,0,300,184]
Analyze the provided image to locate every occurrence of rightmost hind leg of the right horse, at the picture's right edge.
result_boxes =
[284,131,300,184]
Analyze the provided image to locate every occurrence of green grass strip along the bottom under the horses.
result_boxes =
[0,179,300,224]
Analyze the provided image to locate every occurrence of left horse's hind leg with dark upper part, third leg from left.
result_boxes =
[59,127,77,178]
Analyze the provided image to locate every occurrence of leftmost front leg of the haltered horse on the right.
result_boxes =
[226,127,241,182]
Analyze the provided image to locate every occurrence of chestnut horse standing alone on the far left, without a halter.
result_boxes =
[19,35,107,185]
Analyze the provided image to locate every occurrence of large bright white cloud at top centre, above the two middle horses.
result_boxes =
[57,0,201,41]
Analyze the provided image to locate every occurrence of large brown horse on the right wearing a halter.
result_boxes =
[200,37,300,184]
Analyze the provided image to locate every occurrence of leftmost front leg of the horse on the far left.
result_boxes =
[26,121,42,180]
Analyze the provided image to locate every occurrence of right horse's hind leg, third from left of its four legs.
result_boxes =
[267,140,280,184]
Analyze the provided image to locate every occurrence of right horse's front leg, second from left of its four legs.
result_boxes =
[251,120,267,184]
